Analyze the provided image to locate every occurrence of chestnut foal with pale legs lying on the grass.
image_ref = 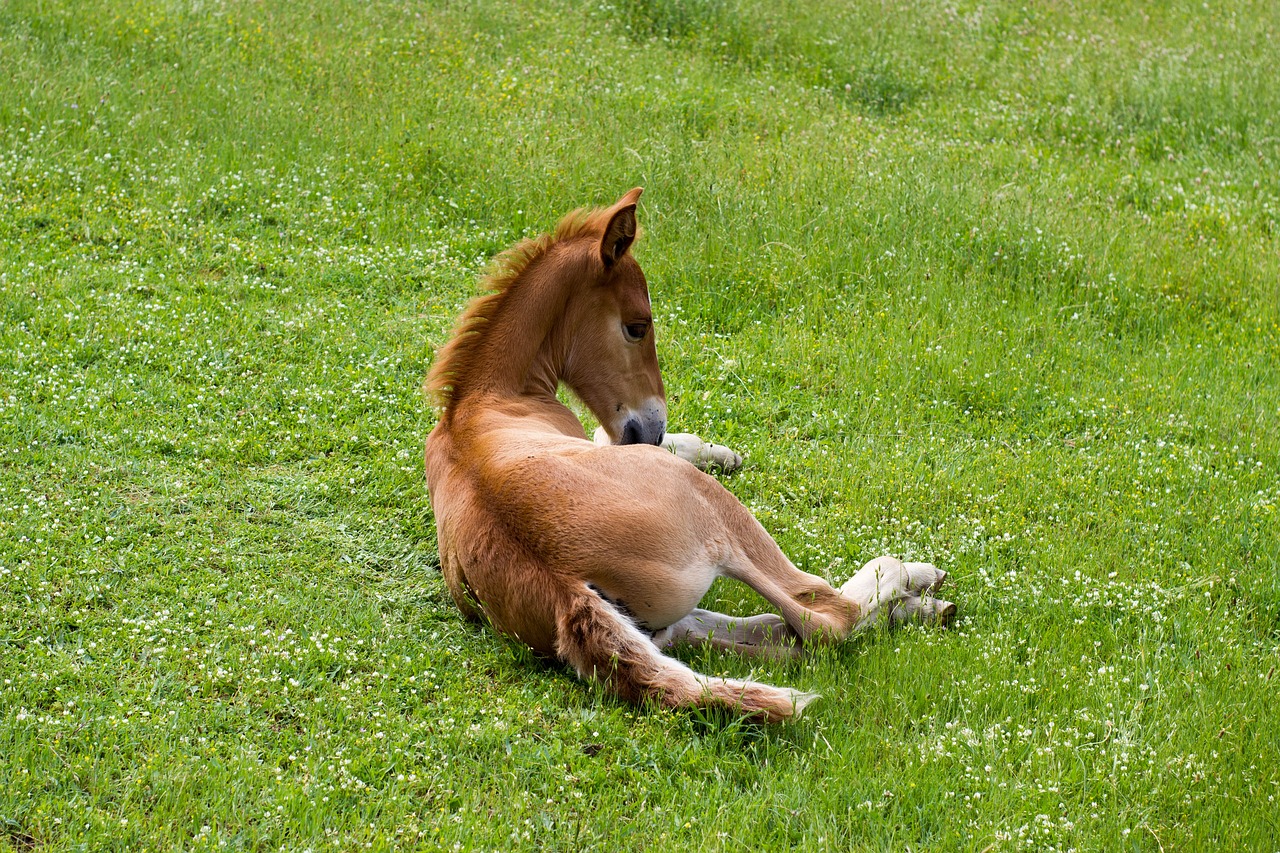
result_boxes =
[425,187,956,722]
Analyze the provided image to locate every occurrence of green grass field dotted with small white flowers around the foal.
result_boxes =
[0,0,1280,852]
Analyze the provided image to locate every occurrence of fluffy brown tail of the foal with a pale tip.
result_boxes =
[556,584,818,722]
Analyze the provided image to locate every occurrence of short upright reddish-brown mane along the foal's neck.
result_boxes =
[424,207,619,412]
